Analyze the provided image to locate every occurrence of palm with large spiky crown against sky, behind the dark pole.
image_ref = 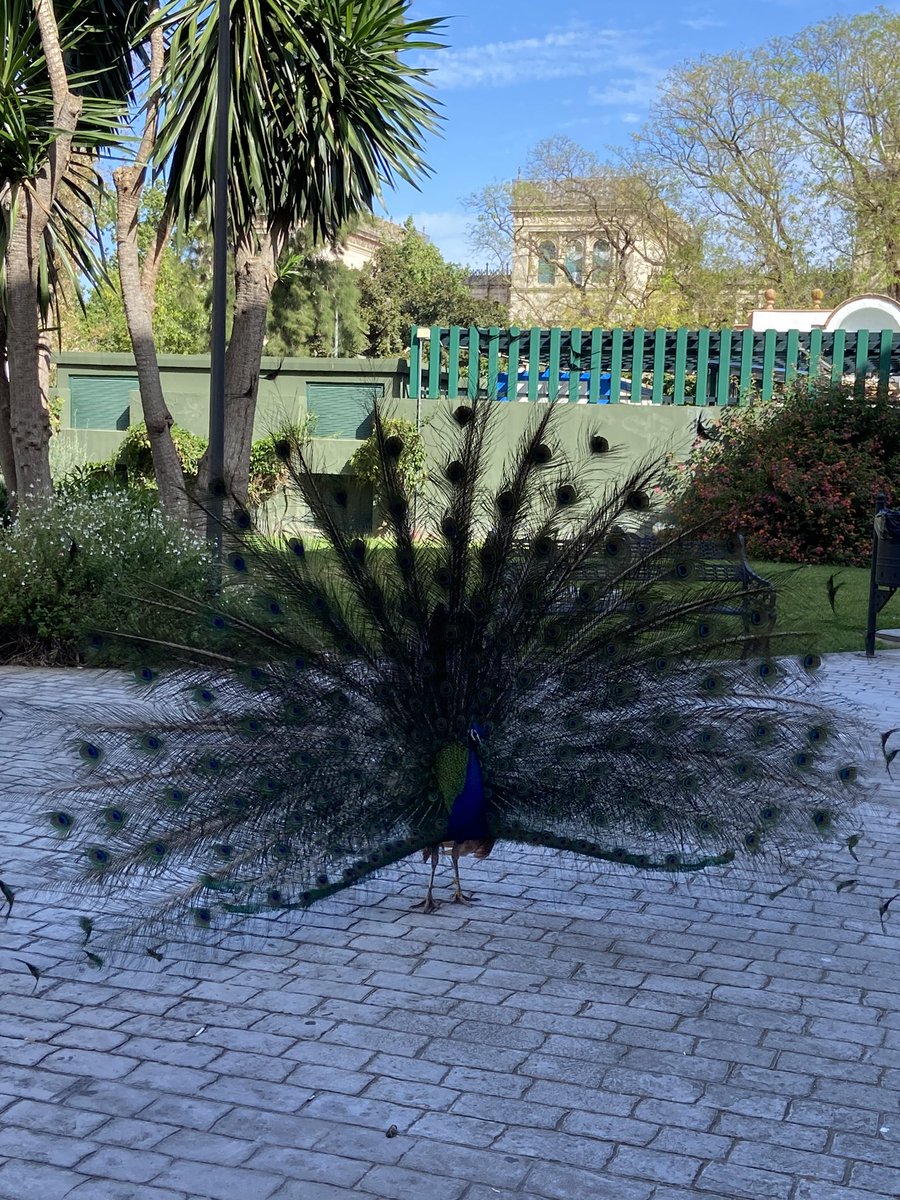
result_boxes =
[157,0,442,502]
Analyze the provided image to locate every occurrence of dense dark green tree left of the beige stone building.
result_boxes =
[360,217,508,356]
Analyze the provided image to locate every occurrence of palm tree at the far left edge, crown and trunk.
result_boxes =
[0,0,145,497]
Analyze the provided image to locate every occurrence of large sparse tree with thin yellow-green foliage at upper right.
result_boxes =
[636,7,900,306]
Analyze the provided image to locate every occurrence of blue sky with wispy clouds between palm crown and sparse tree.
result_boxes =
[384,0,898,268]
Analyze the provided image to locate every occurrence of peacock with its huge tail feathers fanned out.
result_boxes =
[19,398,862,960]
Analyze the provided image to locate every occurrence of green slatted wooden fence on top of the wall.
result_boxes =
[409,325,900,404]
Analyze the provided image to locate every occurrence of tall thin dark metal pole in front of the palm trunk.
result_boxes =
[206,0,232,556]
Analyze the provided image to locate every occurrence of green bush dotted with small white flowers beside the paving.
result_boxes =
[0,485,211,664]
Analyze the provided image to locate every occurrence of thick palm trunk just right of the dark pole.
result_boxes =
[198,228,283,505]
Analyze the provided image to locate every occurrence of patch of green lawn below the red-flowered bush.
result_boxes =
[752,563,900,654]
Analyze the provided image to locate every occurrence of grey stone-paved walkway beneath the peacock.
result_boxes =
[0,652,900,1200]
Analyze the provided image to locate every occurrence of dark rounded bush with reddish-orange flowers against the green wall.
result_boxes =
[665,382,900,566]
